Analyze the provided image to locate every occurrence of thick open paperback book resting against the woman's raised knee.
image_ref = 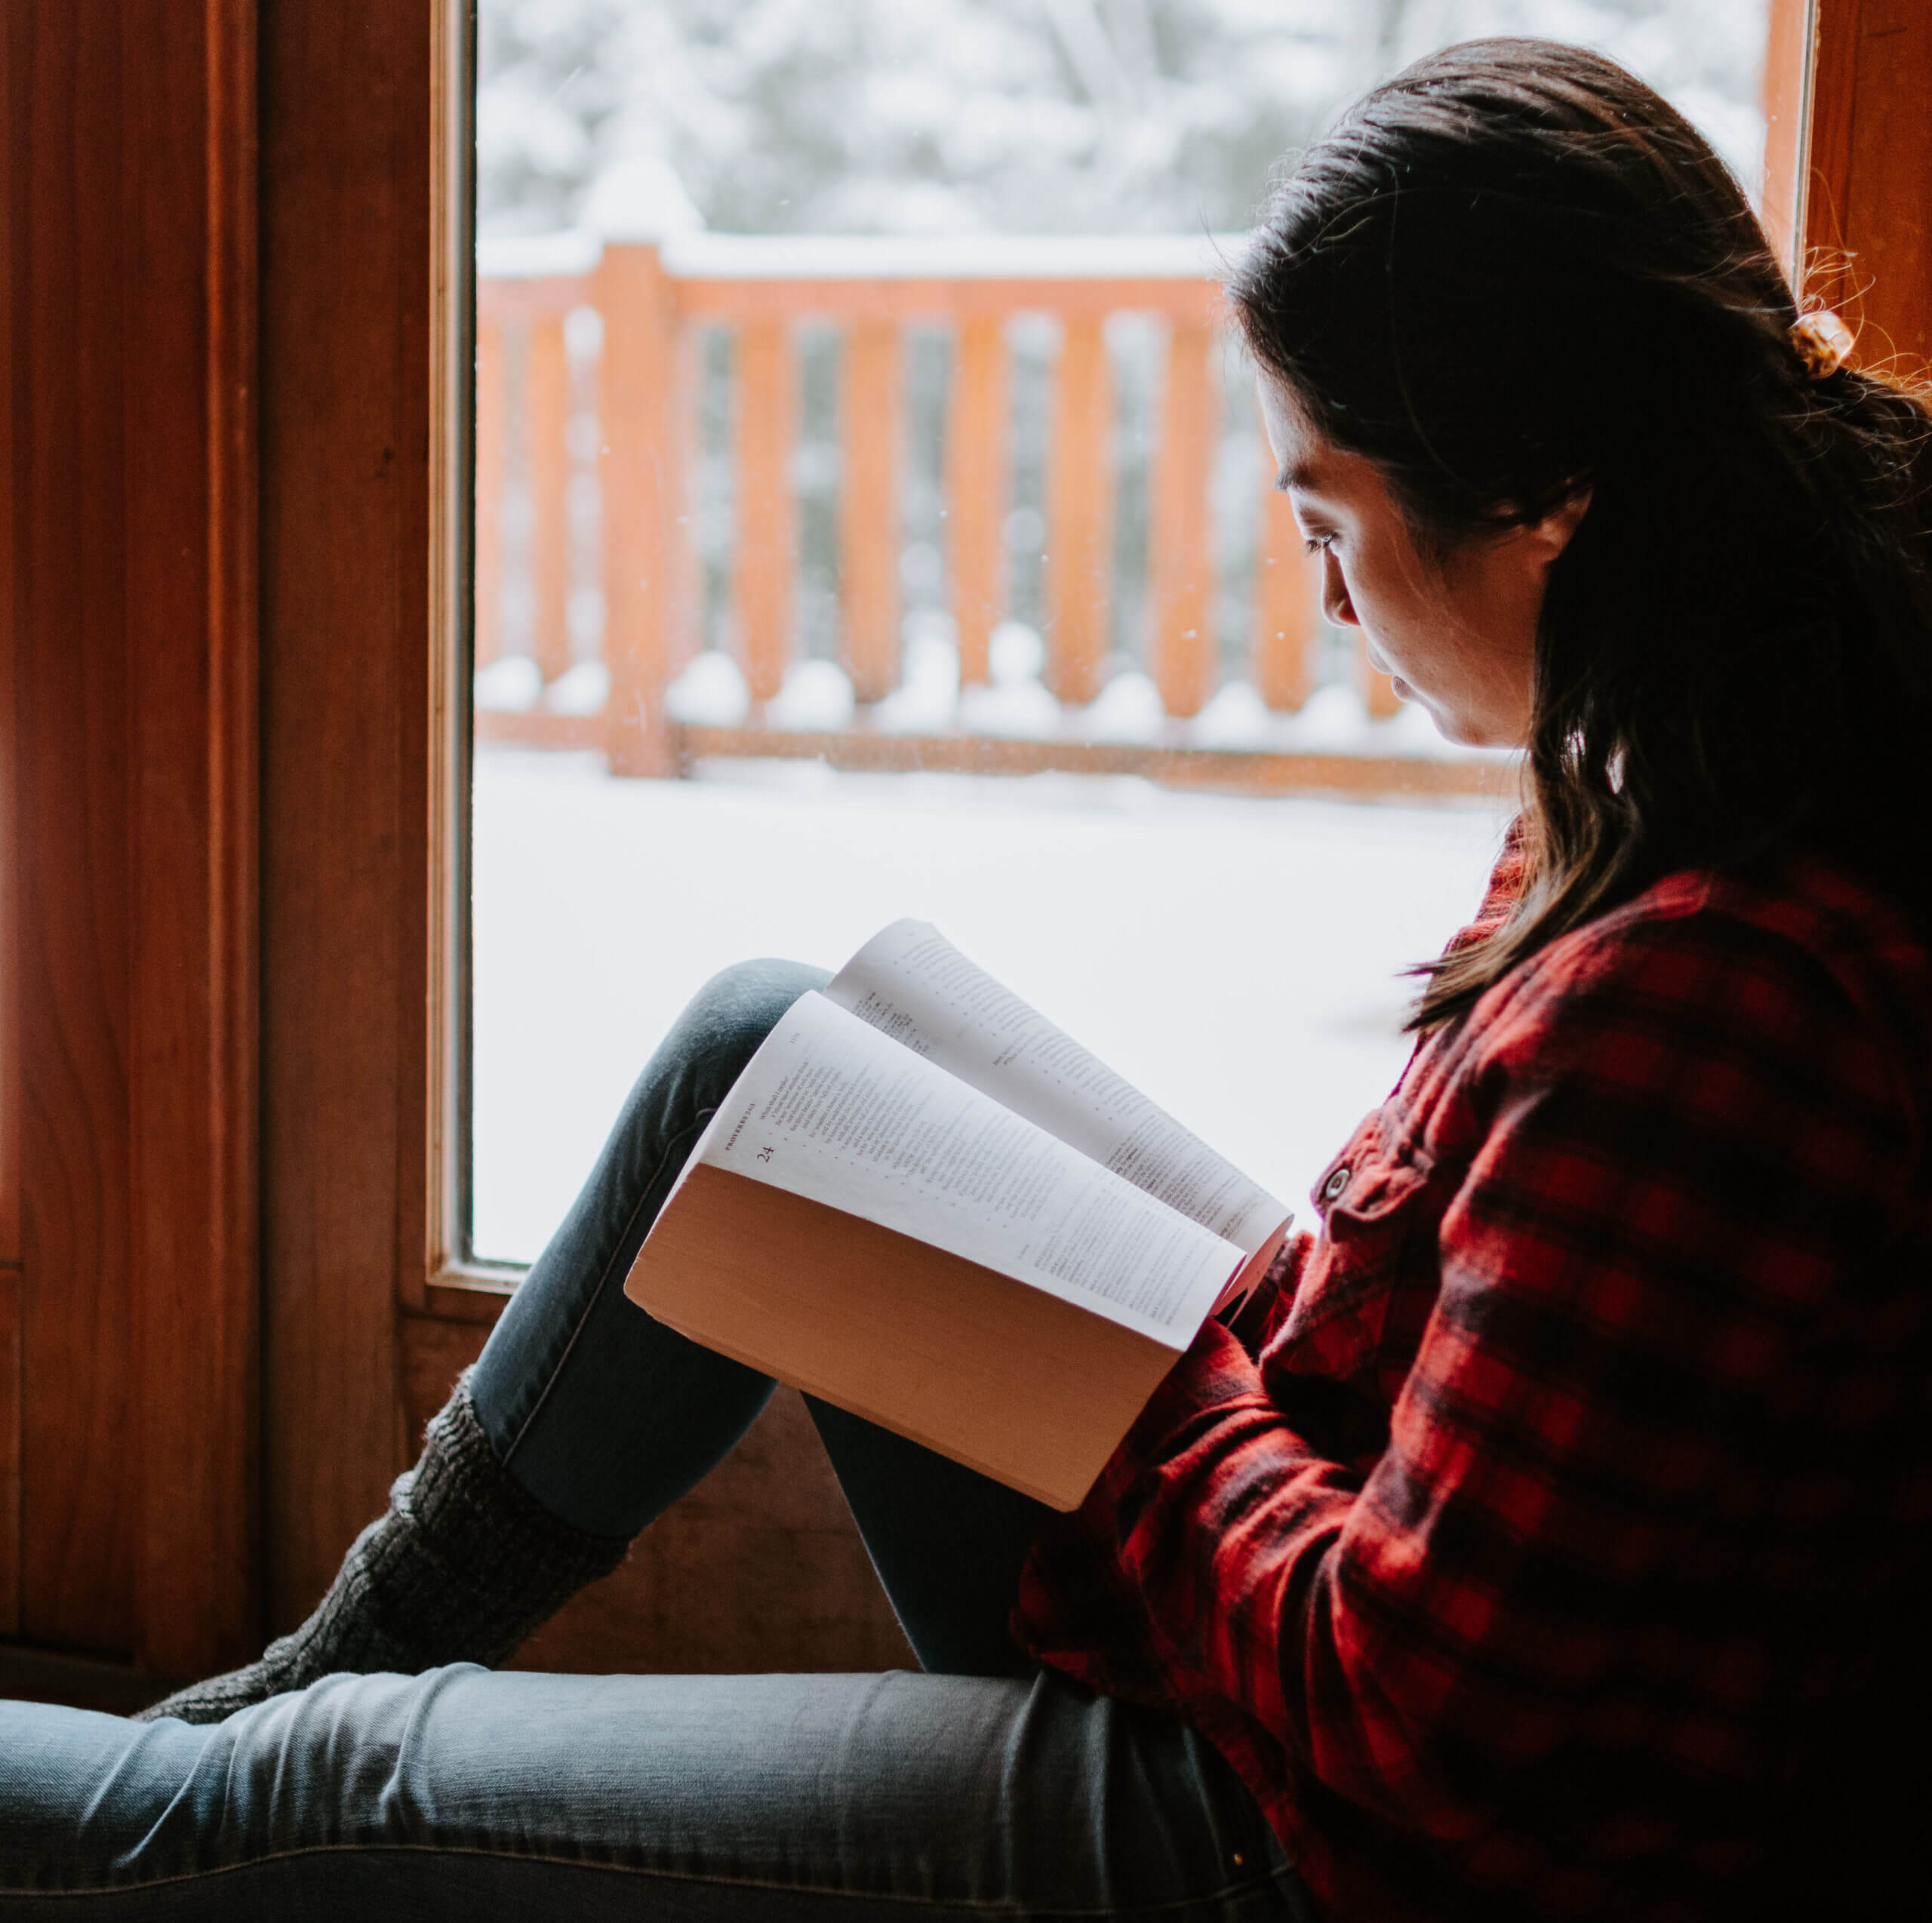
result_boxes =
[626,922,1289,1509]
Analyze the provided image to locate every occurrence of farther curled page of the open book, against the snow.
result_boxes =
[825,922,1289,1254]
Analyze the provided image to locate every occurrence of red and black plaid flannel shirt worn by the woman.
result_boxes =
[1014,854,1932,1923]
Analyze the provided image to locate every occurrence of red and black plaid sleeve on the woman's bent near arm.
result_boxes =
[1045,914,1917,1841]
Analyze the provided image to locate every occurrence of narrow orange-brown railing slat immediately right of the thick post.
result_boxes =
[732,321,798,702]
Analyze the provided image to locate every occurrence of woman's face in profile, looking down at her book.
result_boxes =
[1260,375,1588,748]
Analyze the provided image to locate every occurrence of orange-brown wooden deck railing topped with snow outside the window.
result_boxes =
[475,234,1495,790]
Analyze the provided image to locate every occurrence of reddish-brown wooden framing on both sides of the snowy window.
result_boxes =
[0,0,1932,1681]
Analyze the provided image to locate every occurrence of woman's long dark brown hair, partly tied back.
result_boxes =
[1229,41,1932,1028]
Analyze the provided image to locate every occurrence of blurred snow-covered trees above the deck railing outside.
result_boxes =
[477,0,1766,234]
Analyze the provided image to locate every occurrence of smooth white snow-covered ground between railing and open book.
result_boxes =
[473,748,1503,1260]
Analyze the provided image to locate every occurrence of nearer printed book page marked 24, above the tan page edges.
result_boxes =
[691,993,1242,1349]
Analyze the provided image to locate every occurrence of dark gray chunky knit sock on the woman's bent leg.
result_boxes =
[137,1374,630,1722]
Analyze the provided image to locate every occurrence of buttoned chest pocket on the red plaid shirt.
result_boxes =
[1267,1109,1434,1388]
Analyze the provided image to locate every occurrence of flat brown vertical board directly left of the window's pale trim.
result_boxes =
[261,0,438,1629]
